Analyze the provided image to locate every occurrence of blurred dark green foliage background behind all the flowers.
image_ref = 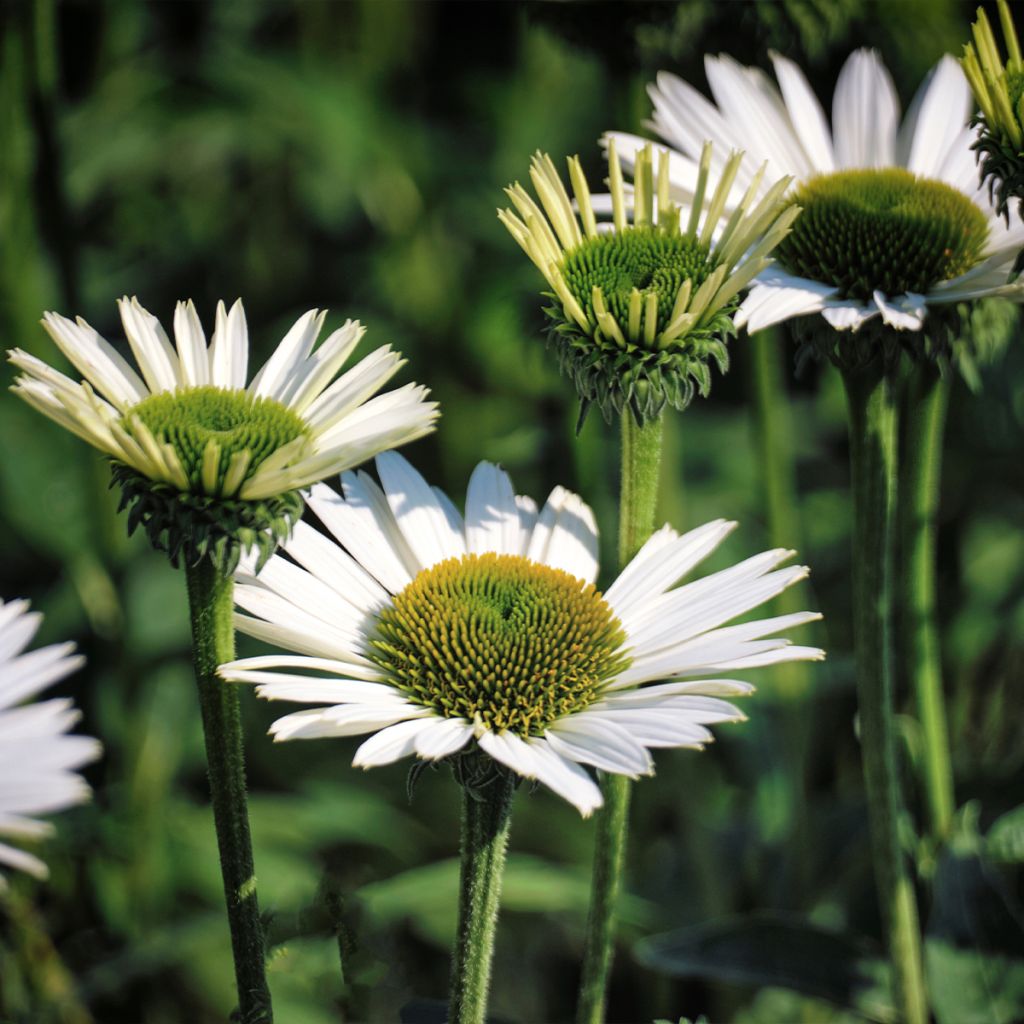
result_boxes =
[0,0,1024,1024]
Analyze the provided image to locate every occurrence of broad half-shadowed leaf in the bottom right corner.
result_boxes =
[925,813,1024,1024]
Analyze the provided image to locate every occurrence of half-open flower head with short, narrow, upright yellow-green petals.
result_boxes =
[498,144,798,422]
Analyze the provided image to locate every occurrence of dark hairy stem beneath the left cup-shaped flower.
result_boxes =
[185,558,273,1024]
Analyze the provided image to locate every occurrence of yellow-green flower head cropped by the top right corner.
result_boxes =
[961,0,1024,218]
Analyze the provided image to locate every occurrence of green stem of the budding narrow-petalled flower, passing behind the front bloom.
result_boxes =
[577,413,663,1024]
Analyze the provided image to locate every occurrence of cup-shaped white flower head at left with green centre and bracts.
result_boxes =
[10,298,437,569]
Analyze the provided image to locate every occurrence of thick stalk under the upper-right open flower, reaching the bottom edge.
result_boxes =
[843,359,929,1024]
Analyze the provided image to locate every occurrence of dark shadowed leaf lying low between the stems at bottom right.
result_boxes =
[634,913,896,1022]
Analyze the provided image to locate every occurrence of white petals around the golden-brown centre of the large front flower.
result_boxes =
[219,454,823,815]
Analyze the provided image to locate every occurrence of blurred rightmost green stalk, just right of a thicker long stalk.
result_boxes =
[900,364,955,840]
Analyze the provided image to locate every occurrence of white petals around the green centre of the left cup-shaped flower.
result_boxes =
[10,297,437,501]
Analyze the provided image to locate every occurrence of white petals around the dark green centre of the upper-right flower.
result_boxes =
[630,50,1024,332]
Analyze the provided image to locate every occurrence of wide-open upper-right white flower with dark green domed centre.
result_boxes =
[607,50,1024,331]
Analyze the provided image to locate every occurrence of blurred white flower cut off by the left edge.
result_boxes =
[0,601,100,889]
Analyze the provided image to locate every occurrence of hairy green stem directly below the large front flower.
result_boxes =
[447,771,515,1024]
